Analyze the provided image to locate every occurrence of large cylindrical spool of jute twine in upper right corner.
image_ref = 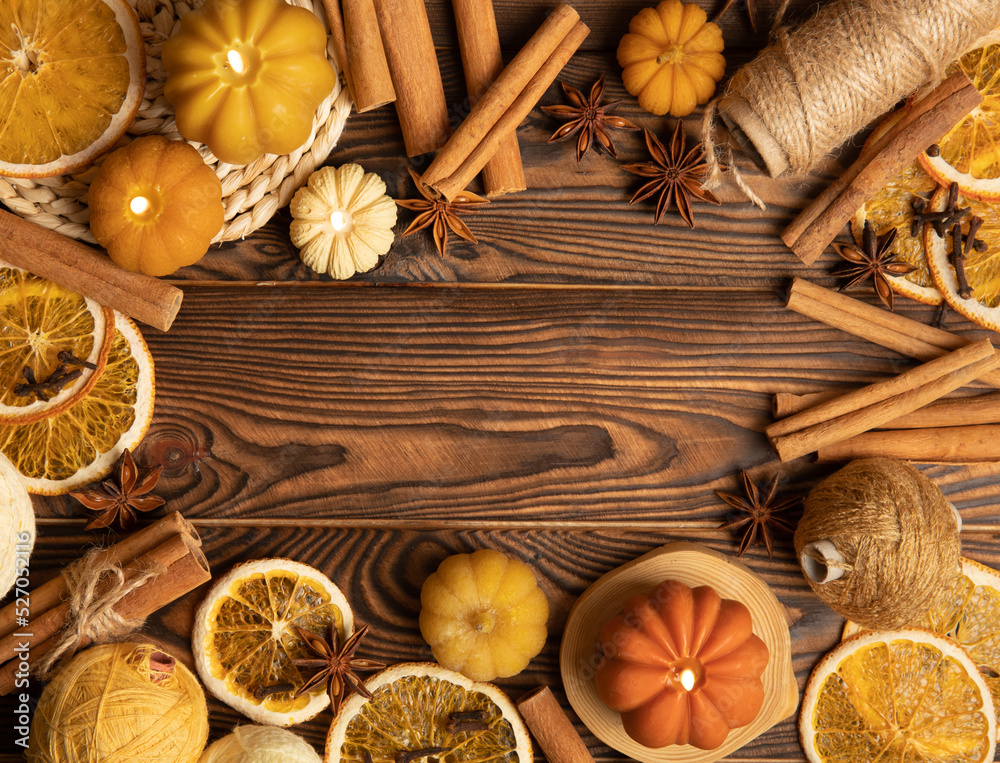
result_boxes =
[705,0,1000,180]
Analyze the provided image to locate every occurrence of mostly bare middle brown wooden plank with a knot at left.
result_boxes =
[25,285,1000,524]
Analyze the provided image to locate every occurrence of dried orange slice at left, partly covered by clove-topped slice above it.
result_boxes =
[0,313,155,495]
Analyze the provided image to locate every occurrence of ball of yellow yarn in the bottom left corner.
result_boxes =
[28,644,208,763]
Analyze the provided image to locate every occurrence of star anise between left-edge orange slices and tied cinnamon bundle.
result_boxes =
[70,448,166,532]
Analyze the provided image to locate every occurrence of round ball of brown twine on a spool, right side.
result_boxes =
[795,458,961,629]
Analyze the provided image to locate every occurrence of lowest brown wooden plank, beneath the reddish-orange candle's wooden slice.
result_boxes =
[11,521,1000,761]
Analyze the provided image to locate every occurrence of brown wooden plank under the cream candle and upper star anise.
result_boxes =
[174,51,853,289]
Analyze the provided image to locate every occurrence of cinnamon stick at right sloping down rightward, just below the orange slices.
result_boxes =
[785,278,1000,387]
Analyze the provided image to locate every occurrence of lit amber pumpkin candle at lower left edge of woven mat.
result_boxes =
[88,135,224,276]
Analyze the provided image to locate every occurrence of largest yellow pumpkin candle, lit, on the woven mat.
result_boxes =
[162,0,337,164]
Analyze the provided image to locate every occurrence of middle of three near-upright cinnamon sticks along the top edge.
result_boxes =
[375,0,451,156]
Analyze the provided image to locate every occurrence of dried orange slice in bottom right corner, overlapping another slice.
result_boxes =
[799,628,997,763]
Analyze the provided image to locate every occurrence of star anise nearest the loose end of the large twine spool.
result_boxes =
[622,120,722,228]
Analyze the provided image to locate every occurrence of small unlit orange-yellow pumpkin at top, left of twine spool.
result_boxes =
[618,0,726,117]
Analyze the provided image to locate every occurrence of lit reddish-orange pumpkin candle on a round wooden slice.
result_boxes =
[596,580,769,750]
